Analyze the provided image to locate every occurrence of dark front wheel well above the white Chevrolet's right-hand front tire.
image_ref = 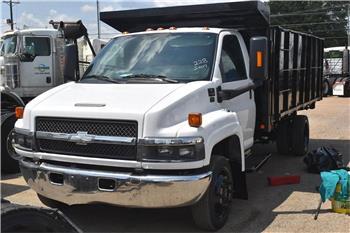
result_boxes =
[212,135,241,164]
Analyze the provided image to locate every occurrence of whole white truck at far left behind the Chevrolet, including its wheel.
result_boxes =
[0,21,101,173]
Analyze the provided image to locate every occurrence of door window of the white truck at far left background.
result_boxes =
[24,37,51,56]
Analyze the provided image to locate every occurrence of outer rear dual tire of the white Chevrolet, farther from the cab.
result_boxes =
[292,115,309,156]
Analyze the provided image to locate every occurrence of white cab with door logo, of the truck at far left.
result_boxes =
[1,29,64,99]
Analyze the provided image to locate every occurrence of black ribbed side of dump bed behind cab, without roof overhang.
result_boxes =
[255,27,324,135]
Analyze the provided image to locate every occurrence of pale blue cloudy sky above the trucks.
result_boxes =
[1,0,232,39]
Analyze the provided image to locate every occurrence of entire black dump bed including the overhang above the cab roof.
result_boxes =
[100,1,323,135]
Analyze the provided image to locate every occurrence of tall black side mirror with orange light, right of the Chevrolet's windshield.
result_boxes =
[249,37,268,82]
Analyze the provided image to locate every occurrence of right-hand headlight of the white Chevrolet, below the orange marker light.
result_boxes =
[139,137,205,162]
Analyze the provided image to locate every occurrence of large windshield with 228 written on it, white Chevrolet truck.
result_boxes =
[81,33,217,82]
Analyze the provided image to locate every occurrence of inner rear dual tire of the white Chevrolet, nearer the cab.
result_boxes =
[276,119,291,155]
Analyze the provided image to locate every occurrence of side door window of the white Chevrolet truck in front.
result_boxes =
[220,35,247,82]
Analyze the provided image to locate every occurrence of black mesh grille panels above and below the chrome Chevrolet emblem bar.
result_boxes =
[36,117,137,160]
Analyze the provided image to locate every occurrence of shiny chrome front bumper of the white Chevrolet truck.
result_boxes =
[19,159,212,208]
